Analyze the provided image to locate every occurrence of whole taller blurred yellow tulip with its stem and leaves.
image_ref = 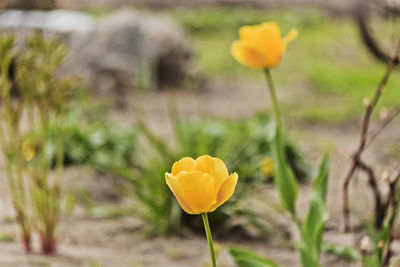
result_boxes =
[230,23,329,267]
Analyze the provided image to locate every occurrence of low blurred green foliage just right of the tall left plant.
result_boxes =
[40,119,137,169]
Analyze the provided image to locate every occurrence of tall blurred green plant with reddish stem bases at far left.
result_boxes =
[0,33,77,254]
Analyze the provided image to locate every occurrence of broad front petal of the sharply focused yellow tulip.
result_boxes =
[177,170,217,214]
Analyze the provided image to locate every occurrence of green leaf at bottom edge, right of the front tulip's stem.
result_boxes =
[228,247,279,267]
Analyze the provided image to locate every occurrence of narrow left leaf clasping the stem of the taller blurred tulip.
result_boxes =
[272,127,298,216]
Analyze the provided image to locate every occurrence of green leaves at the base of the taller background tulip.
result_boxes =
[234,120,329,267]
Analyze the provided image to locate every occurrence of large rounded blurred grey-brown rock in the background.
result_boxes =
[70,10,191,94]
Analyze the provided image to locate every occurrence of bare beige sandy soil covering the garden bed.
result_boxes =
[0,76,400,267]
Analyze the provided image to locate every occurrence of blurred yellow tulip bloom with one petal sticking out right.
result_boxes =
[231,22,298,69]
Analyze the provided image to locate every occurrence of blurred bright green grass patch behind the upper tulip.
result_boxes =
[168,7,400,123]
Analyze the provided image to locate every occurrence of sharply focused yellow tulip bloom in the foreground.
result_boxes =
[165,155,238,214]
